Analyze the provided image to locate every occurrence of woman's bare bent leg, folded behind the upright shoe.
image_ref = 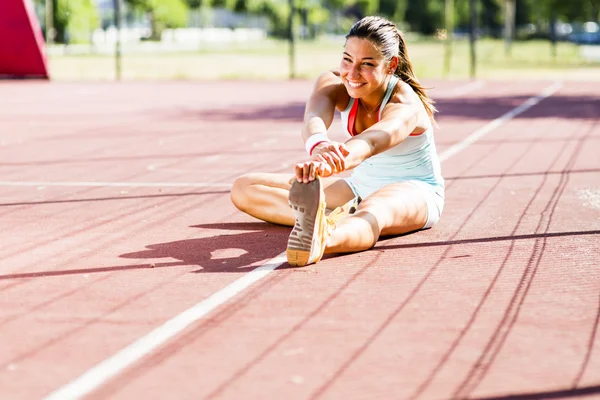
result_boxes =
[231,173,354,226]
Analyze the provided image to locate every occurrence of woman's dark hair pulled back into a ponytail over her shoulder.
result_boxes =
[346,16,437,121]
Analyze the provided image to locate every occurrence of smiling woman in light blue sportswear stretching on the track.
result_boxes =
[231,17,444,266]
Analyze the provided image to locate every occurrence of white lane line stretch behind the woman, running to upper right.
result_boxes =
[439,82,563,162]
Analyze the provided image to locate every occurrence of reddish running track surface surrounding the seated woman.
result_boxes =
[0,81,600,399]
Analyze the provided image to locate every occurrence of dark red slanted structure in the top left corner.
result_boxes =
[0,0,49,79]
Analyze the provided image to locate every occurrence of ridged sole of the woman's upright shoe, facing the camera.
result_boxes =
[286,179,325,267]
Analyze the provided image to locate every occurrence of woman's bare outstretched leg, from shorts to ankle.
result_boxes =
[325,183,427,254]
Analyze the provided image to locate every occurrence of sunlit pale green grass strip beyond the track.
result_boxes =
[49,37,600,81]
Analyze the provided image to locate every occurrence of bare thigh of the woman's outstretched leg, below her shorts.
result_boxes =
[357,182,428,236]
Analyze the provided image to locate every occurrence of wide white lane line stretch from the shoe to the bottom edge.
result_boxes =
[45,252,286,400]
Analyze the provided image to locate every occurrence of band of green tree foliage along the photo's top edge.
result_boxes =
[34,0,600,41]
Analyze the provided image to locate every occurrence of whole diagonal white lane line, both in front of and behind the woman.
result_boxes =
[44,79,561,400]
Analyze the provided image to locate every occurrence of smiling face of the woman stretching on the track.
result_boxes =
[340,37,390,98]
